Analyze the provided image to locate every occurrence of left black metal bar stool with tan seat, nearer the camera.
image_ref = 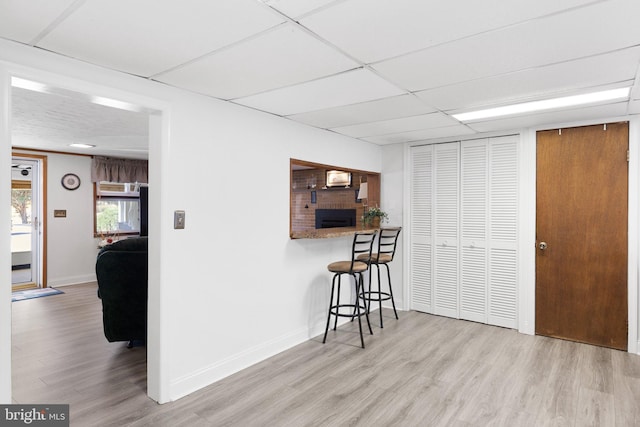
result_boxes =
[322,230,378,348]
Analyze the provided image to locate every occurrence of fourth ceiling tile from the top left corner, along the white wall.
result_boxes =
[234,69,403,116]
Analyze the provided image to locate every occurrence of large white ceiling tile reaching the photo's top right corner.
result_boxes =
[374,0,640,91]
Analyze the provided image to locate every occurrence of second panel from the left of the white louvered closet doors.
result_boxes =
[433,142,460,317]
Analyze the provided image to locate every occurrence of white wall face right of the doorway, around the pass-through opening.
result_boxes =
[159,88,381,397]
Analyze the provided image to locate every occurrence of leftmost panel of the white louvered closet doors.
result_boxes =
[409,145,433,313]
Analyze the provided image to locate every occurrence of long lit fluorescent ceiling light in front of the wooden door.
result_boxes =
[452,87,631,122]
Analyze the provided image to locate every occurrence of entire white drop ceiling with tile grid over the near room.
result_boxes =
[0,0,640,156]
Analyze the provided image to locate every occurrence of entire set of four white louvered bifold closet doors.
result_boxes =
[409,136,518,328]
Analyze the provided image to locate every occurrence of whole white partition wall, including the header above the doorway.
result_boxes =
[0,41,384,402]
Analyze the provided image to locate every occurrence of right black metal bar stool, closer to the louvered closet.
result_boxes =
[358,227,402,328]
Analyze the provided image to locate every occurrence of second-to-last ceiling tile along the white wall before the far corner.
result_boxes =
[331,113,459,138]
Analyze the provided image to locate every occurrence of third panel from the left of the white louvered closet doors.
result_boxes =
[460,139,489,323]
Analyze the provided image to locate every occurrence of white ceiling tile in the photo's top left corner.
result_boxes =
[0,0,75,43]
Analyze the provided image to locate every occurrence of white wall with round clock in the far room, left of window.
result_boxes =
[14,150,98,287]
